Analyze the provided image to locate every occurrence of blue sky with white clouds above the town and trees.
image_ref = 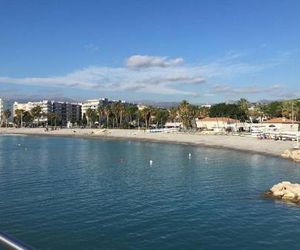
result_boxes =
[0,0,300,103]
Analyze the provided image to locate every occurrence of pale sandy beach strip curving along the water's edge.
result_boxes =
[0,128,295,156]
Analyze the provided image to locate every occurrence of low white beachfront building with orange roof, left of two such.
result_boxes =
[196,117,244,132]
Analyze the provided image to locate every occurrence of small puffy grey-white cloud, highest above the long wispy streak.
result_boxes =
[126,55,183,69]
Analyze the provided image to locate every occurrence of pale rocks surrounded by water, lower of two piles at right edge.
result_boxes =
[266,181,300,203]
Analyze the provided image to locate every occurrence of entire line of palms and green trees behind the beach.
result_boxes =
[2,98,300,128]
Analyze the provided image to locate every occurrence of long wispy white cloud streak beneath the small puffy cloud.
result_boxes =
[0,67,205,96]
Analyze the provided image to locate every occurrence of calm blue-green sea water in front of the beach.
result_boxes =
[0,136,300,250]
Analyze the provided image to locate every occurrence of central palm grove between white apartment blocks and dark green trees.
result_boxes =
[82,100,208,129]
